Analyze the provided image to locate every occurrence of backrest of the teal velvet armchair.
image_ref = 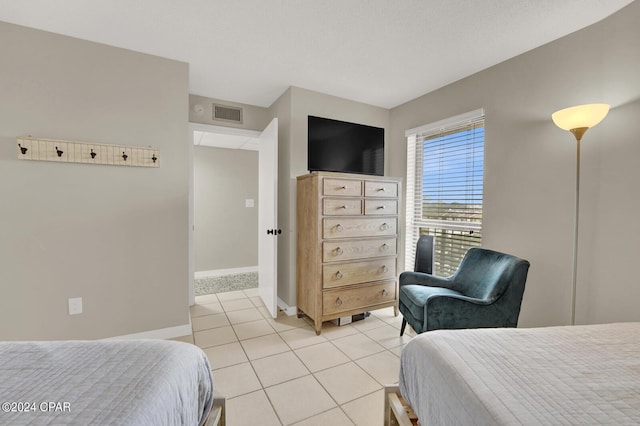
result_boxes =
[451,247,529,303]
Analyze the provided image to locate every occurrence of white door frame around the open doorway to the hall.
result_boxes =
[188,122,262,306]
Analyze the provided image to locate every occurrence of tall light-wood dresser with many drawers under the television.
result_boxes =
[296,172,401,334]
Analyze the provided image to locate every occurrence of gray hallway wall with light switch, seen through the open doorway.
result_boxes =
[193,146,258,272]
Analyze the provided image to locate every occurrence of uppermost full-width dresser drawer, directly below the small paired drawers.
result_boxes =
[322,217,397,239]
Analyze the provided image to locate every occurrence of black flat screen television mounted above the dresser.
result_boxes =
[307,115,384,176]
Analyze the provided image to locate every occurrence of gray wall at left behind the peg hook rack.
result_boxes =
[0,22,189,340]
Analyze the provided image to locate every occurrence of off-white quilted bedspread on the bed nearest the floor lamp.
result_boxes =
[399,323,640,426]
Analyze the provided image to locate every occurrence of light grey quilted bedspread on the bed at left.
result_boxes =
[0,340,220,425]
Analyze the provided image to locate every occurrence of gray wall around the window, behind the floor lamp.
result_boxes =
[390,2,640,326]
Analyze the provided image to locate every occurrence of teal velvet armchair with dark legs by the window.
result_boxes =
[399,247,529,336]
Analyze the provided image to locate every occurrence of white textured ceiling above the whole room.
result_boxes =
[0,0,632,108]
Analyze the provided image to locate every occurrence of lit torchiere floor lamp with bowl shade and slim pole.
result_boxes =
[551,104,609,325]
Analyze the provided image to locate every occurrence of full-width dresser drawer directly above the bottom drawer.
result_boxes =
[322,257,396,288]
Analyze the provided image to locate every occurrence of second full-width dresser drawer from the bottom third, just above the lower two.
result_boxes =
[322,238,396,262]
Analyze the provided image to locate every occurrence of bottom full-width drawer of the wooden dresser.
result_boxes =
[322,281,396,315]
